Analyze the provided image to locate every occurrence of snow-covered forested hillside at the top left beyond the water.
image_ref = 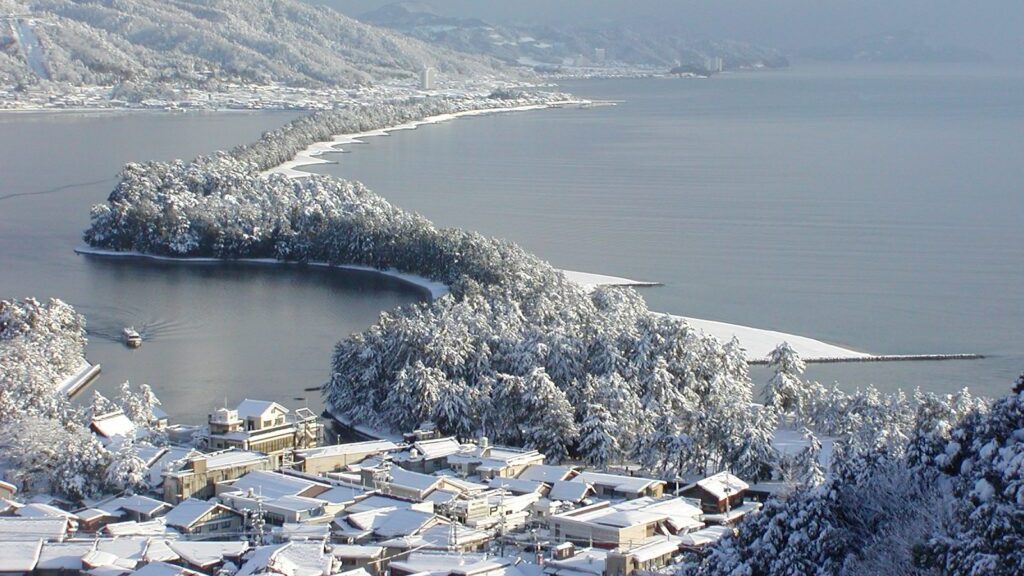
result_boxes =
[0,0,502,88]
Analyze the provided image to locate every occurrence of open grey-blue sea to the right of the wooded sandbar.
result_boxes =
[313,65,1024,396]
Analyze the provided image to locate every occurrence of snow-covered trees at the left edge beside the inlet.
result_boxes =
[0,298,161,499]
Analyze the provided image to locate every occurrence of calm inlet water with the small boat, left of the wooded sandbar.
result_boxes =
[0,113,421,422]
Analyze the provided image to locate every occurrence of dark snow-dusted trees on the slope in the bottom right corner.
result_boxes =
[679,381,1024,576]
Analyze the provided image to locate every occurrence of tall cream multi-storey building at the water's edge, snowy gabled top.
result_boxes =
[208,399,323,468]
